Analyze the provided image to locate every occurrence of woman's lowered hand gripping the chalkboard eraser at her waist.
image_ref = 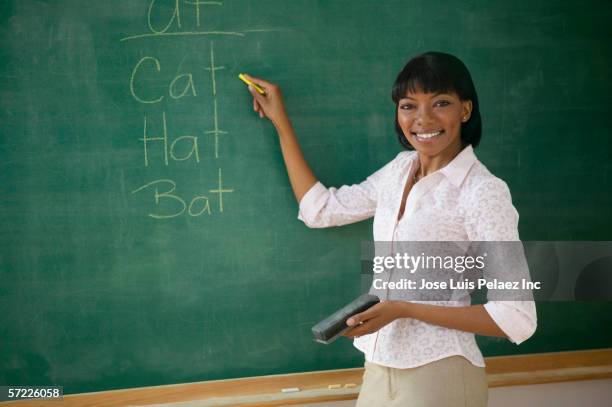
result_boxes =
[344,301,406,338]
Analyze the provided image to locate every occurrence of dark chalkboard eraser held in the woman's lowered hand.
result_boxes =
[312,294,380,345]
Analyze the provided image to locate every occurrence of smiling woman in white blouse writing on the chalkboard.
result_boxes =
[244,52,536,407]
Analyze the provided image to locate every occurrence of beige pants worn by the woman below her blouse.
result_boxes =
[355,356,488,407]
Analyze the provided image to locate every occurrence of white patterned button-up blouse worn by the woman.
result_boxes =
[298,146,537,368]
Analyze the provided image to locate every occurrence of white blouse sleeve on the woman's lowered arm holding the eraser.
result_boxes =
[466,178,537,345]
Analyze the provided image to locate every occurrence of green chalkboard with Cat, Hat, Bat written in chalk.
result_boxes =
[0,0,612,393]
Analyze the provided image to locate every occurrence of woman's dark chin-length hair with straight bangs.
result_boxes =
[391,51,482,150]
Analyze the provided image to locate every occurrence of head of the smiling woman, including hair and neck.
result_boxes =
[391,52,482,183]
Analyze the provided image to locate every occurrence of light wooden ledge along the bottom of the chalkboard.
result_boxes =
[8,348,612,406]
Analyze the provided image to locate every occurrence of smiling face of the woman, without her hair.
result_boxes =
[397,92,472,157]
